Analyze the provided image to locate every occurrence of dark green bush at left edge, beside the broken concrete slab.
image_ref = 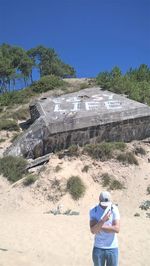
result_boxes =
[0,156,27,182]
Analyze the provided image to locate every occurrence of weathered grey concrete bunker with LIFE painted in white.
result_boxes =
[6,88,150,158]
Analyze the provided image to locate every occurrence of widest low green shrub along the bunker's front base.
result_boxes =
[83,142,126,161]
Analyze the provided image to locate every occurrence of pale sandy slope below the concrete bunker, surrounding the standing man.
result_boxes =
[0,140,150,266]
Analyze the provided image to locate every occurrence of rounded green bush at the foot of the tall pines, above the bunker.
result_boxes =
[30,75,66,93]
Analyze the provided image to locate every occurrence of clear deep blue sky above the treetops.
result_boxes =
[0,0,150,77]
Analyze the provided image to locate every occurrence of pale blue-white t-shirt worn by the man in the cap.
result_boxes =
[90,204,120,249]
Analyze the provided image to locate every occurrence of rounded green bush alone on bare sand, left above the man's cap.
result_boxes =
[67,176,86,200]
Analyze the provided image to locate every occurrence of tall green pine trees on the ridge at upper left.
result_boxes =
[0,44,75,93]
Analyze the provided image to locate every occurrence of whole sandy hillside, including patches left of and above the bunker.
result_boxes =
[0,79,150,266]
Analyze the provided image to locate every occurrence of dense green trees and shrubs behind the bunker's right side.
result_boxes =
[96,64,150,105]
